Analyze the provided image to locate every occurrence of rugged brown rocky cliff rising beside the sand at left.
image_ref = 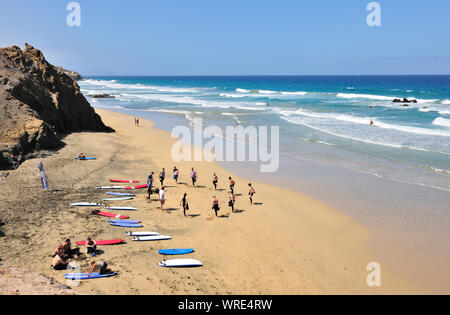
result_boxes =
[0,44,114,169]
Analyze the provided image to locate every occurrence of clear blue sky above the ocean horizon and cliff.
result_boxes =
[0,0,450,75]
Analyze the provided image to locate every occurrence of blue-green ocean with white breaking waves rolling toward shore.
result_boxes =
[79,76,450,191]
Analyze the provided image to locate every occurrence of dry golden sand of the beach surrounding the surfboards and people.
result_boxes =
[0,108,418,294]
